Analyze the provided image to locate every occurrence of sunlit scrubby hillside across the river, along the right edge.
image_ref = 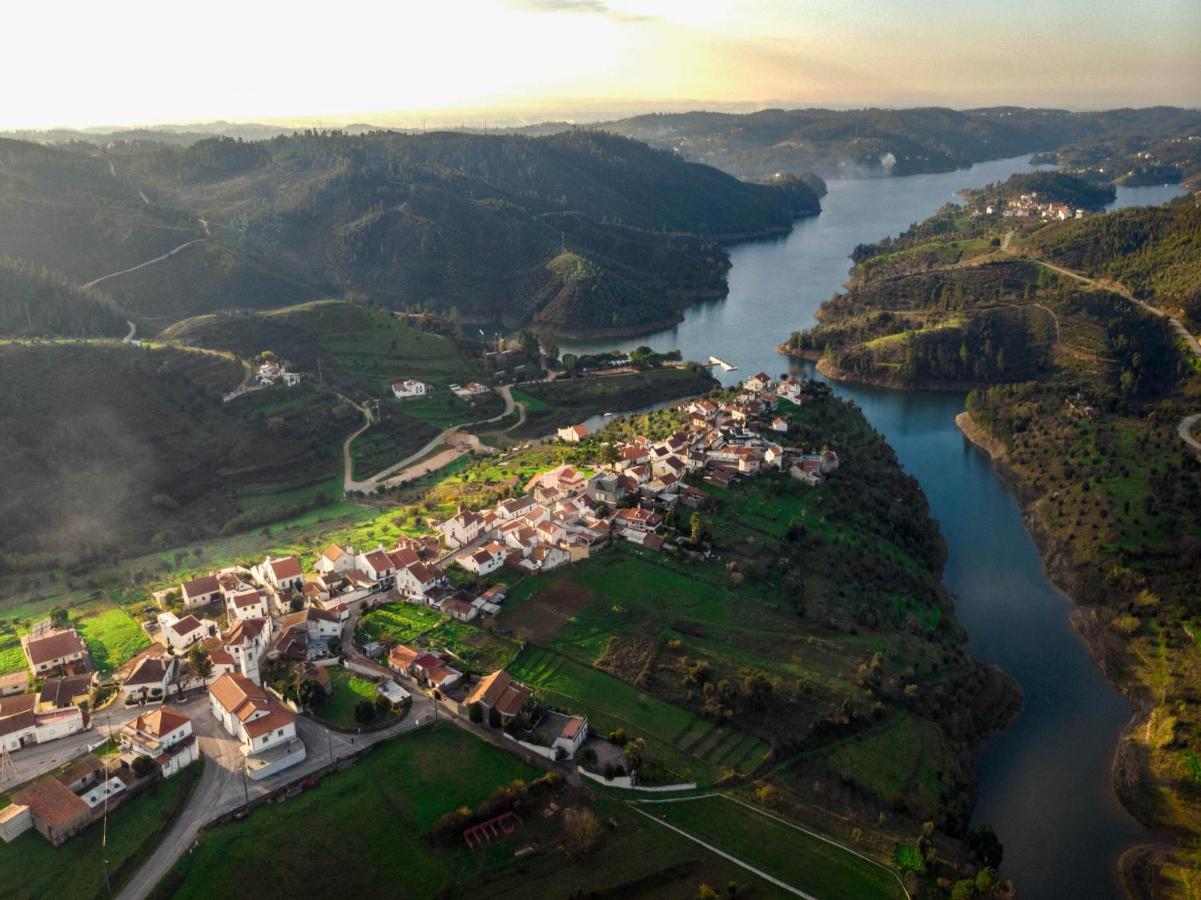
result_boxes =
[789,194,1201,896]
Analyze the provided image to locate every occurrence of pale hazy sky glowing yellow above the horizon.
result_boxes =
[0,0,1201,127]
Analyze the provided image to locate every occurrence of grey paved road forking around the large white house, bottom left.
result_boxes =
[118,693,435,900]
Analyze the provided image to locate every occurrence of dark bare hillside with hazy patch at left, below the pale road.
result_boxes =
[0,344,360,571]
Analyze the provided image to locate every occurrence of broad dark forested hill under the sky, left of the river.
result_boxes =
[0,132,820,332]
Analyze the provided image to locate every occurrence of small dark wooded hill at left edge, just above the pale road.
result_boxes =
[0,258,129,338]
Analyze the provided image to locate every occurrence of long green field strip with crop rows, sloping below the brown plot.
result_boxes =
[508,646,767,783]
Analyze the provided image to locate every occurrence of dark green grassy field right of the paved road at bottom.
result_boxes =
[156,726,540,898]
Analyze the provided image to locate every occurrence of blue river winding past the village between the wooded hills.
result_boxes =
[560,163,1183,899]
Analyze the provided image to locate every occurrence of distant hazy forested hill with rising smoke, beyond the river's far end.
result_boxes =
[586,107,1201,179]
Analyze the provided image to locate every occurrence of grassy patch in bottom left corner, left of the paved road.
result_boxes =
[0,764,202,900]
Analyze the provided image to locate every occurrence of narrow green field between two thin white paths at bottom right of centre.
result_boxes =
[643,797,906,900]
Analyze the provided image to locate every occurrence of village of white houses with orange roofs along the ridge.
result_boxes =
[0,372,838,845]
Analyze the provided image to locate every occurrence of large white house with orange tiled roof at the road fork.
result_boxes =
[209,674,305,781]
